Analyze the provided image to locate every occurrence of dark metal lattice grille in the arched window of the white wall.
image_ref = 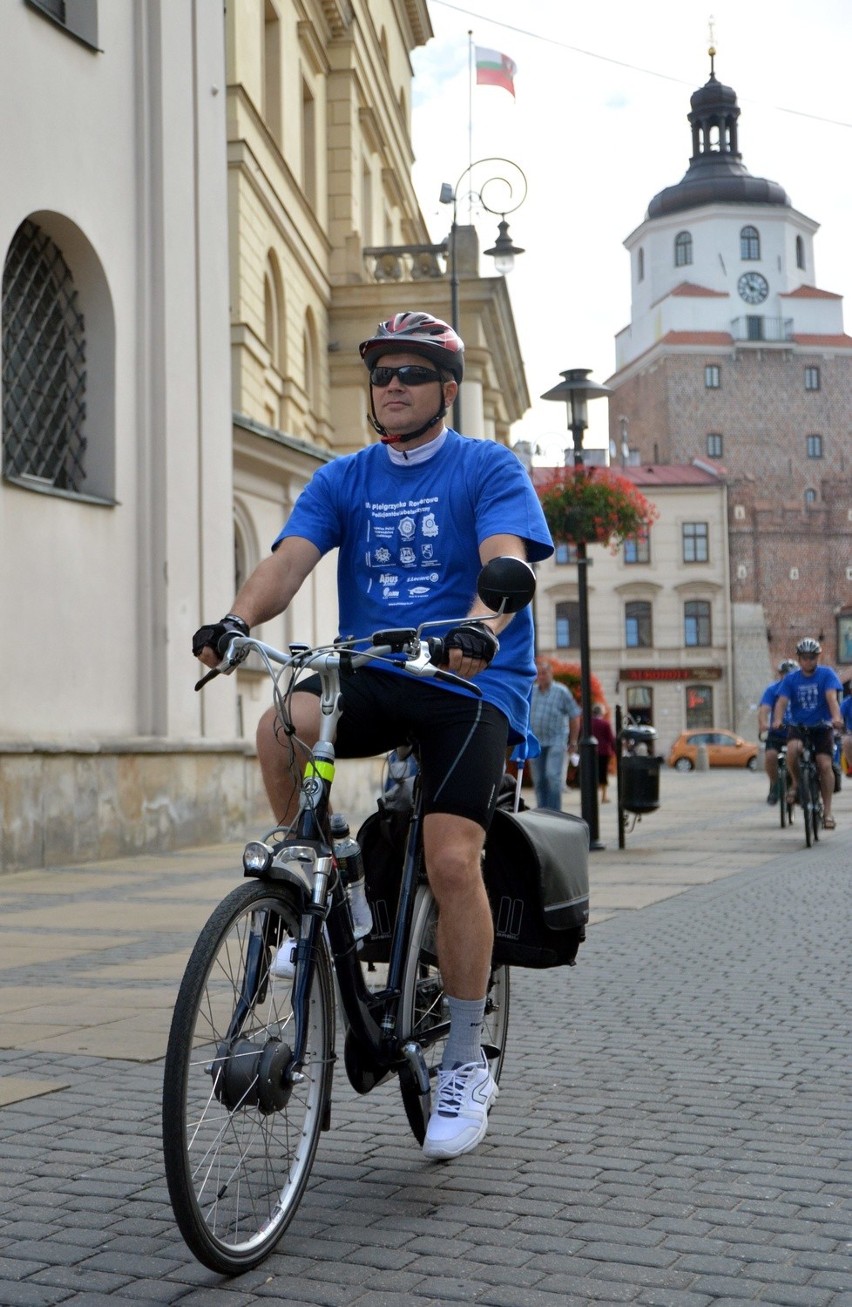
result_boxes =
[3,220,86,493]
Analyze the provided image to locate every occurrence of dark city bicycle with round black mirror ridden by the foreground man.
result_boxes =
[162,558,534,1274]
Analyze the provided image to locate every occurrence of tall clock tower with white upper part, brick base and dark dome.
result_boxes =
[608,48,852,732]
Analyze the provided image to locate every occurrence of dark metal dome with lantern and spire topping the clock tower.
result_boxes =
[647,47,791,218]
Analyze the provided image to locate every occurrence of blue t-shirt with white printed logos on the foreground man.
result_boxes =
[272,431,553,742]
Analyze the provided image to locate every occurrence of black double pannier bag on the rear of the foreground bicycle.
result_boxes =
[358,802,589,968]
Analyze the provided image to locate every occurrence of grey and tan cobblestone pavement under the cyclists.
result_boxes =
[0,771,852,1307]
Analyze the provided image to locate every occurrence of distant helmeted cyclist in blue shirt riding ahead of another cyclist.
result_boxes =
[772,637,843,830]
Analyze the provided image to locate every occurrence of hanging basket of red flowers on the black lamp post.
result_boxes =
[538,467,659,552]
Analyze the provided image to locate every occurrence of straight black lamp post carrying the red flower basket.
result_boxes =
[541,367,612,850]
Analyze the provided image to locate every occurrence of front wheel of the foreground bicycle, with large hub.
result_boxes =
[162,882,335,1274]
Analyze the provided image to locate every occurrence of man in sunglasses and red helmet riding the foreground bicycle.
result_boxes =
[193,312,553,1158]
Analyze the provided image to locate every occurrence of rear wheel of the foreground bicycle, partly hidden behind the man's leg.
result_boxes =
[400,885,510,1144]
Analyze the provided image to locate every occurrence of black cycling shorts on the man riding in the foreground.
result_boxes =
[295,668,508,830]
